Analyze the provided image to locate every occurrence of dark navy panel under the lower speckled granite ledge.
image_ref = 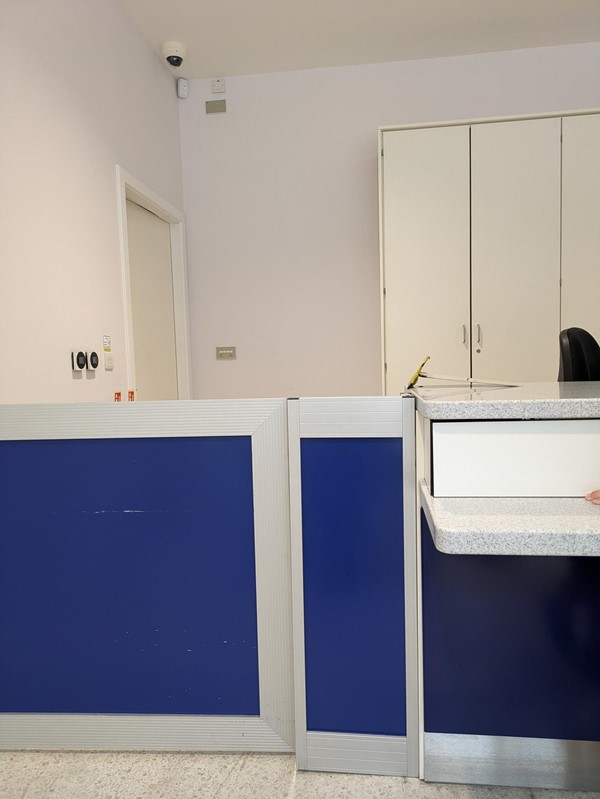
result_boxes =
[422,516,600,741]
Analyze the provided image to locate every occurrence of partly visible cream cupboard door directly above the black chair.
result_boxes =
[561,114,600,342]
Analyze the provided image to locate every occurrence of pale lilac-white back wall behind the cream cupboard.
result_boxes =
[180,44,600,397]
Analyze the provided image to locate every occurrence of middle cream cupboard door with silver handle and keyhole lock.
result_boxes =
[471,118,561,382]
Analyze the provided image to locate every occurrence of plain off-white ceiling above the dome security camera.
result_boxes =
[121,0,600,78]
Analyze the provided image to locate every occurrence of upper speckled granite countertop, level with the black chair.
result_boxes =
[409,380,600,421]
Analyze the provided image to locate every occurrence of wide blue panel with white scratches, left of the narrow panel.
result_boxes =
[0,436,259,715]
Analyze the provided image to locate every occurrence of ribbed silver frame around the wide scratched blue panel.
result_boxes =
[0,400,294,752]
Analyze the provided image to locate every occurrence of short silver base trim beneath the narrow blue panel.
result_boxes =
[306,732,407,777]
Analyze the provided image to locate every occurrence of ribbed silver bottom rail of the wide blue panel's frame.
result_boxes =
[0,713,293,752]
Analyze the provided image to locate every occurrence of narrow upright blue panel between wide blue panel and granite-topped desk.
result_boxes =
[301,438,406,735]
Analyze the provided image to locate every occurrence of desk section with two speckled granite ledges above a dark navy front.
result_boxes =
[415,383,600,790]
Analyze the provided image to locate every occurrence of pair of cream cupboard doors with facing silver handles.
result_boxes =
[380,117,576,394]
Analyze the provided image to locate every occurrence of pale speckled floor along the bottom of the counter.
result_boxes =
[0,752,600,799]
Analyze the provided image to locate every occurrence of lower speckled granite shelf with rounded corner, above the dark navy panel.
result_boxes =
[420,482,600,557]
